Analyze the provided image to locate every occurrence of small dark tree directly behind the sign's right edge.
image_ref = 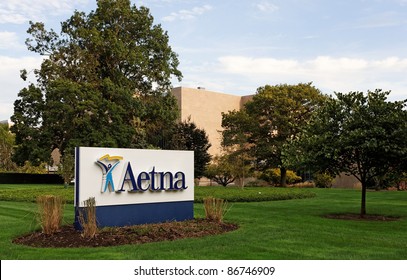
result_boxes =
[170,119,211,179]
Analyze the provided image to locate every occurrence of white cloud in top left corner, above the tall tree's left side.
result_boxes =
[0,0,89,24]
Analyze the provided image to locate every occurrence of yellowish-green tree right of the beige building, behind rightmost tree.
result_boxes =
[222,83,325,186]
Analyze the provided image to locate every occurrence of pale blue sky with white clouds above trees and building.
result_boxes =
[0,0,407,120]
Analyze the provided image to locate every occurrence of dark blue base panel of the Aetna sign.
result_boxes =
[75,201,194,229]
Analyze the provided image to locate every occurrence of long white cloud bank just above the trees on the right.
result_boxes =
[219,56,407,100]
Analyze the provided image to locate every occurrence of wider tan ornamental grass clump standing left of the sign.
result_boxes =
[37,195,65,234]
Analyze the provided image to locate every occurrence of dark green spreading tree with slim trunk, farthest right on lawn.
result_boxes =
[287,89,407,216]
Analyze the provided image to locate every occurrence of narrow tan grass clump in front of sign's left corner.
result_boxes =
[78,197,98,238]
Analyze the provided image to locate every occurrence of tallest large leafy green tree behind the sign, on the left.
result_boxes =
[12,0,182,164]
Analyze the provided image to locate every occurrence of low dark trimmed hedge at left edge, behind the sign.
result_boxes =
[0,173,64,184]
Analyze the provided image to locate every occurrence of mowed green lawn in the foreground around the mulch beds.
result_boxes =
[0,186,407,260]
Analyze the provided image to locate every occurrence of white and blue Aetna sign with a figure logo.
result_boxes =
[75,147,194,226]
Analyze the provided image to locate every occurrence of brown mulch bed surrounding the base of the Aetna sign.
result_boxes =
[13,219,238,248]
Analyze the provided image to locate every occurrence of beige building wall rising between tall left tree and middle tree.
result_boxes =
[172,87,250,155]
